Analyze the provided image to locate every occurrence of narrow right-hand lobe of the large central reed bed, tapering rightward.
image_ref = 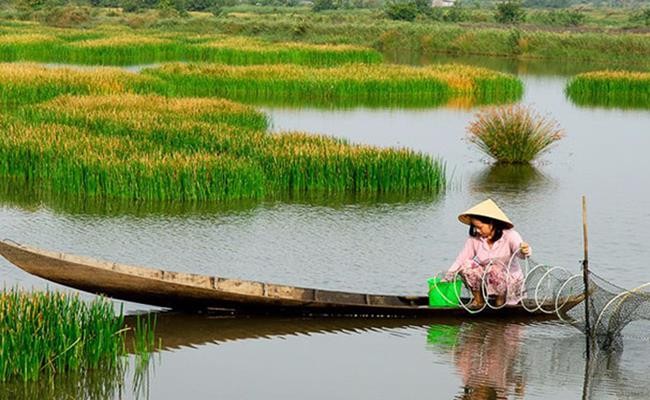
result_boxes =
[261,132,445,194]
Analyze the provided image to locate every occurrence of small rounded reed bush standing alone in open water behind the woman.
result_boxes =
[467,105,564,164]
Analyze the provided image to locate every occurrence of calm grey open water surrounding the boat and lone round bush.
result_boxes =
[0,57,650,399]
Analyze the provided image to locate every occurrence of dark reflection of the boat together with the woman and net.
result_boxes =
[120,313,650,400]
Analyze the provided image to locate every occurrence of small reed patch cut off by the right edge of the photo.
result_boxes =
[565,71,650,109]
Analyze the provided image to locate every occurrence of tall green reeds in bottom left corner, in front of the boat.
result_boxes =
[0,289,153,382]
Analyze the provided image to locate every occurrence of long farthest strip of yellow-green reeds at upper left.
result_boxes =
[0,29,383,66]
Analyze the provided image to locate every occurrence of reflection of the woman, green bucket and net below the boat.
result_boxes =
[427,321,650,400]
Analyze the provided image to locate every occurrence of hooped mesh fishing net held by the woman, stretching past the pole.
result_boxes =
[438,254,650,348]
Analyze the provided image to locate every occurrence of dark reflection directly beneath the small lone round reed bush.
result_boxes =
[471,163,551,194]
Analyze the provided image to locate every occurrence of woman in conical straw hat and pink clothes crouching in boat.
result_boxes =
[446,199,531,308]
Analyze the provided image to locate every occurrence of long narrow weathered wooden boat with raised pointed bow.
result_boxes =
[0,240,583,317]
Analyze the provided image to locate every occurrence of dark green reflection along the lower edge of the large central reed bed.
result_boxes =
[0,177,443,217]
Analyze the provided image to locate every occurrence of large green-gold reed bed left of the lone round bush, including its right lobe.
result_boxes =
[0,94,446,201]
